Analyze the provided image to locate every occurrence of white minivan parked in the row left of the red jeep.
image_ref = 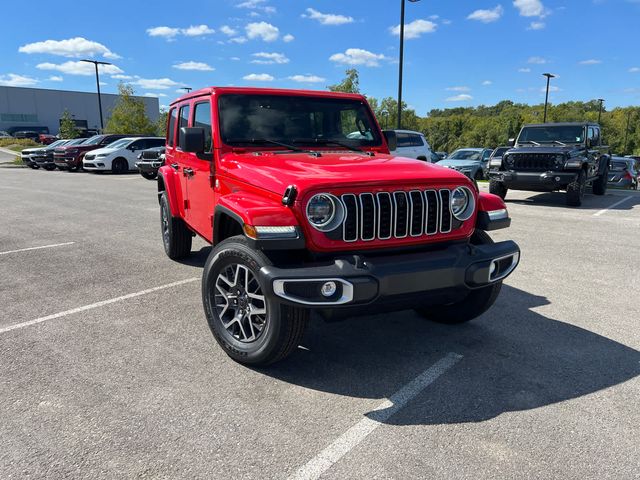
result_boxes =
[82,137,165,173]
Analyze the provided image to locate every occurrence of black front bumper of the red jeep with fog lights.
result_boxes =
[260,241,520,314]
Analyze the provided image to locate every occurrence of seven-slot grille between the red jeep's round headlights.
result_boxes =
[340,189,453,242]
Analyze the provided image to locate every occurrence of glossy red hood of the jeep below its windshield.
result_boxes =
[221,152,469,195]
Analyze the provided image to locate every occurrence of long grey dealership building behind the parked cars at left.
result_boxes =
[0,86,160,135]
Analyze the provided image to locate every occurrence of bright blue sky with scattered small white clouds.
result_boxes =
[0,0,640,115]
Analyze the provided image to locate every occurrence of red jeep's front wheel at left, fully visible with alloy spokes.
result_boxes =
[202,235,309,366]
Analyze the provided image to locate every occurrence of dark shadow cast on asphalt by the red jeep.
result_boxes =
[260,286,640,425]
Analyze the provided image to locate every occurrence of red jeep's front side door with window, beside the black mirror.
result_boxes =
[183,99,214,241]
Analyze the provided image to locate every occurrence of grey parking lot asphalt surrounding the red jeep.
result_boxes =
[0,169,640,479]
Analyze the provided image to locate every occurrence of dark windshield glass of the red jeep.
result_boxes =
[218,94,382,148]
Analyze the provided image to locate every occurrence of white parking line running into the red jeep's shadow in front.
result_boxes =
[289,352,462,480]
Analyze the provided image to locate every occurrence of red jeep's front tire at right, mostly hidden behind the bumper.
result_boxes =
[416,230,502,325]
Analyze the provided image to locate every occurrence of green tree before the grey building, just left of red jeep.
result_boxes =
[105,83,156,135]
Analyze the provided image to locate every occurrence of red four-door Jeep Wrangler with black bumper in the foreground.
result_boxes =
[158,87,520,365]
